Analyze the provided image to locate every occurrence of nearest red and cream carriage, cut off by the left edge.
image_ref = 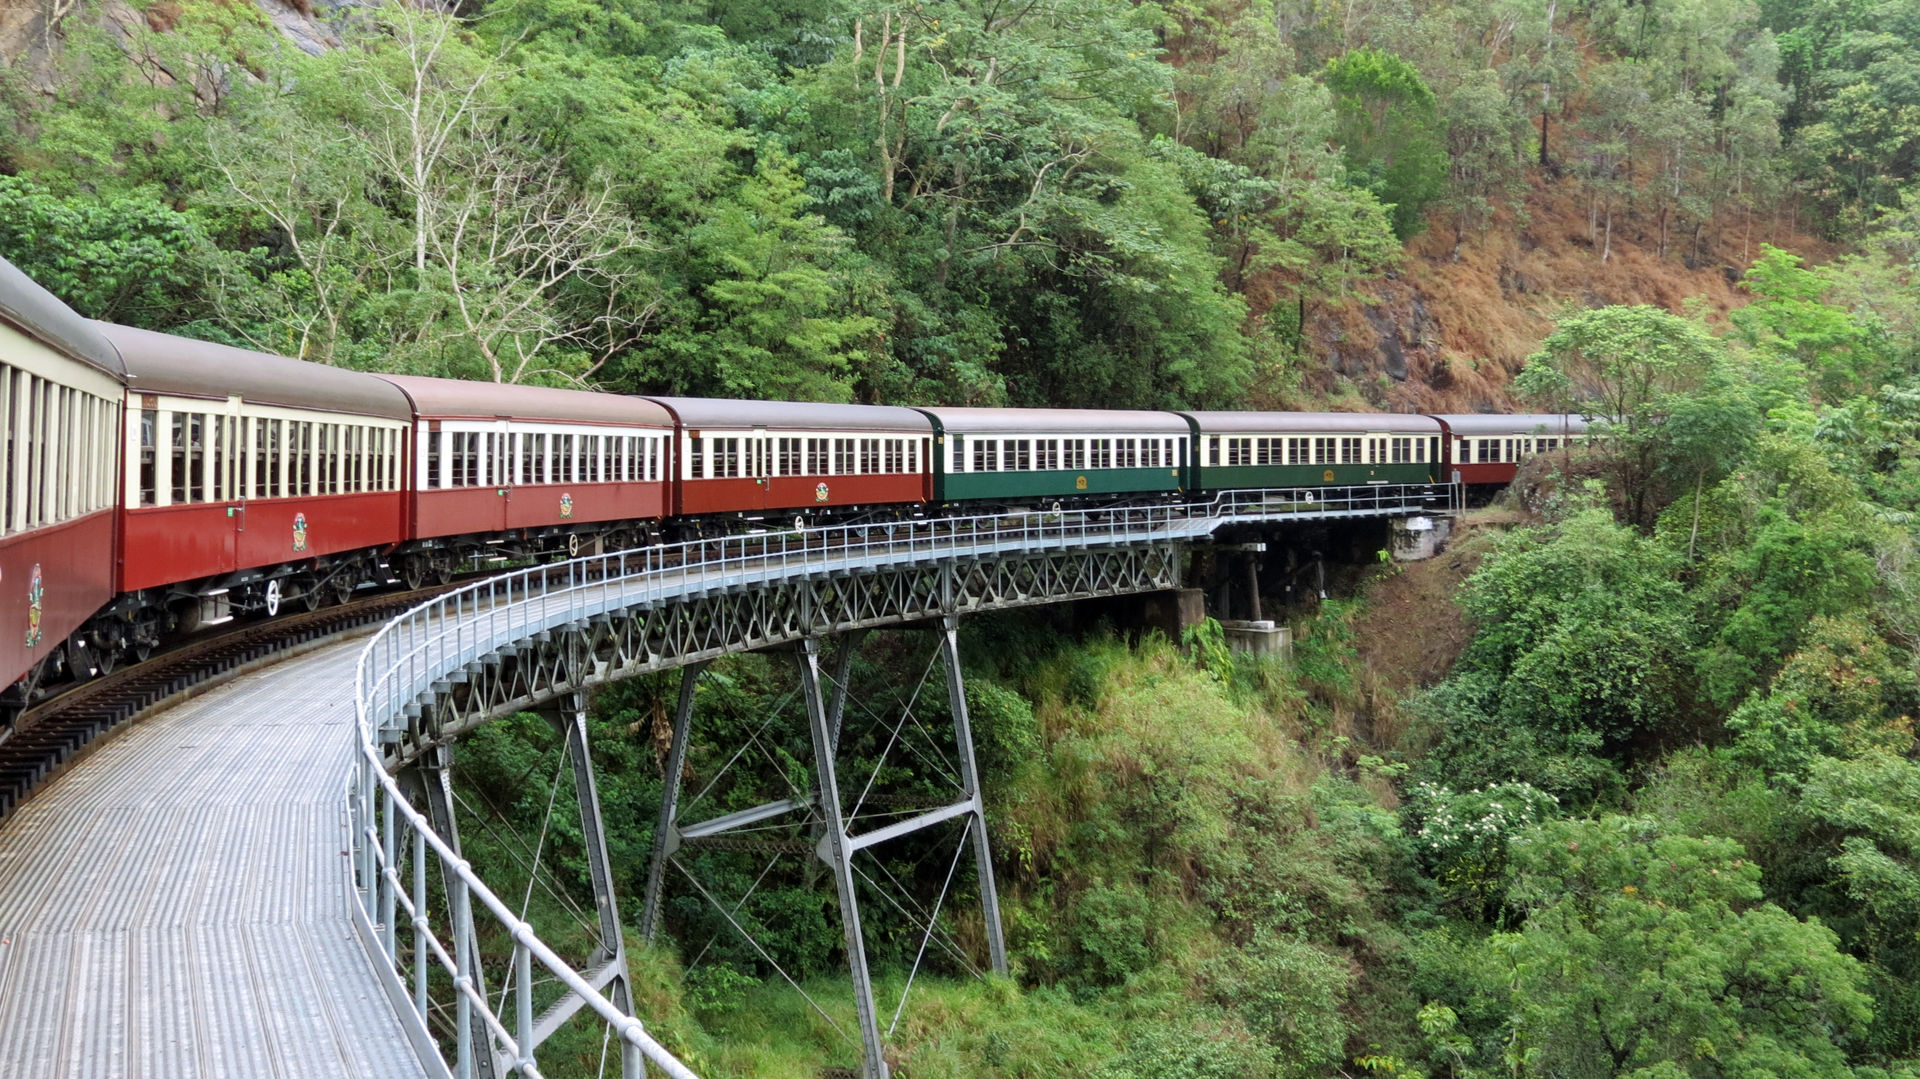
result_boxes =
[0,259,125,702]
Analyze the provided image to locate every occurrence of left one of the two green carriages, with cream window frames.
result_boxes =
[920,409,1192,505]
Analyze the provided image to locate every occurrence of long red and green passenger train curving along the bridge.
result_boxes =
[0,259,1586,724]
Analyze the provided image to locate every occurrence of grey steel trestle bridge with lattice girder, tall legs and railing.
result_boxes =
[346,486,1461,1079]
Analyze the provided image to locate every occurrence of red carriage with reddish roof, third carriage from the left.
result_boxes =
[378,374,674,572]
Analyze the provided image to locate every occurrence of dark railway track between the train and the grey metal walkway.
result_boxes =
[0,582,467,820]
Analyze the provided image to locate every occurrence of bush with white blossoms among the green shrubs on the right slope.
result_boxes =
[1405,781,1559,916]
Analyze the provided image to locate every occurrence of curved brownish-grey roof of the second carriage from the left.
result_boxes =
[92,323,413,420]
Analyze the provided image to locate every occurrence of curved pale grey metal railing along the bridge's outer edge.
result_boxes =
[348,484,1457,1079]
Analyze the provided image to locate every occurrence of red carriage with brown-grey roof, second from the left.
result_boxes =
[94,323,411,625]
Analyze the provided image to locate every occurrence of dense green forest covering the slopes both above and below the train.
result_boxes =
[0,0,1920,1079]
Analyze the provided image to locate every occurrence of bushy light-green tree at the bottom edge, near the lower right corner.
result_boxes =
[1486,816,1872,1079]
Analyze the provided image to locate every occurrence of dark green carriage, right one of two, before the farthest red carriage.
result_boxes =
[1181,413,1442,492]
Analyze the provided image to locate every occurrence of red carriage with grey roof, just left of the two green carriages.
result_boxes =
[647,397,933,524]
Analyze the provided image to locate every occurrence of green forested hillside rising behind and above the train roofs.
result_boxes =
[11,0,1920,389]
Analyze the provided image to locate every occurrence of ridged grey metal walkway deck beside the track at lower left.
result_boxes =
[0,639,422,1079]
